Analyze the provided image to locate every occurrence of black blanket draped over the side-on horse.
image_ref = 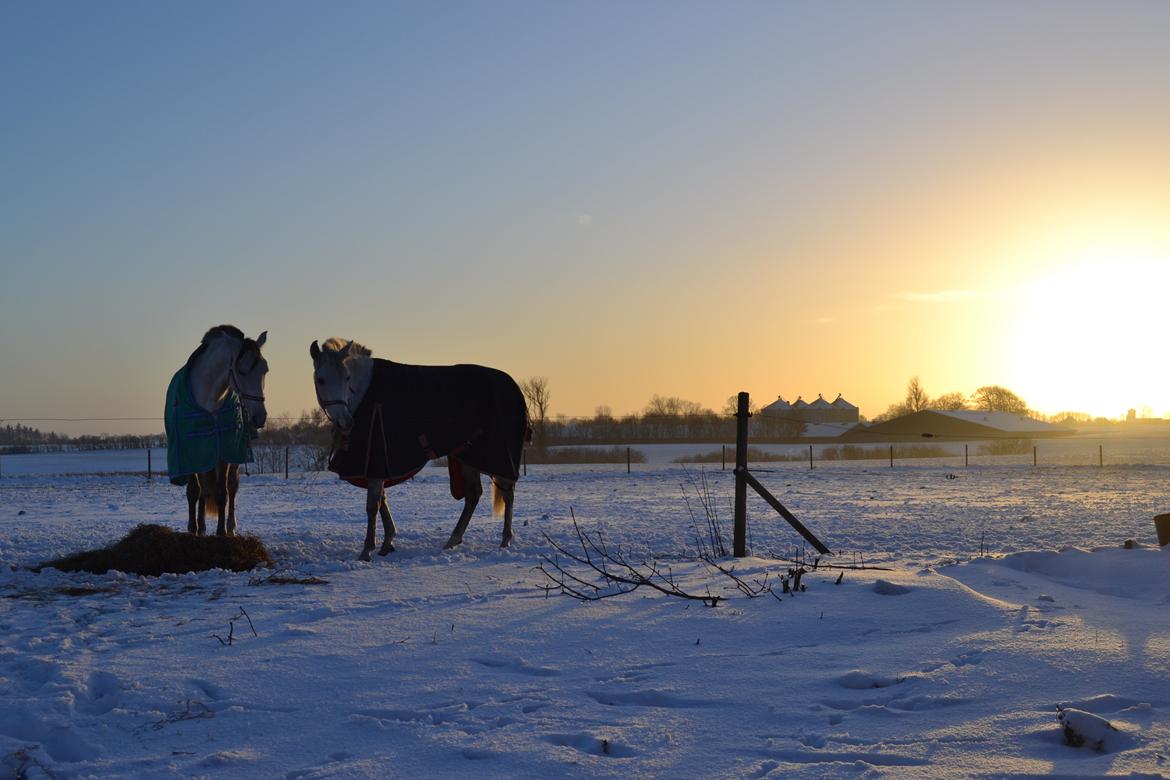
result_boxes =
[329,358,529,488]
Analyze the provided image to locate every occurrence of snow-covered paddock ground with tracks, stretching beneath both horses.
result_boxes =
[0,460,1170,779]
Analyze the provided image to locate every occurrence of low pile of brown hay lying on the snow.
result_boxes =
[42,525,273,577]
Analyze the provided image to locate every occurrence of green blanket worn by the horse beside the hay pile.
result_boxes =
[164,366,255,485]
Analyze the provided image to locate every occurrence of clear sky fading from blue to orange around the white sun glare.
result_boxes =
[0,2,1170,429]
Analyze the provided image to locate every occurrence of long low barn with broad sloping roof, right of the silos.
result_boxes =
[865,409,1074,441]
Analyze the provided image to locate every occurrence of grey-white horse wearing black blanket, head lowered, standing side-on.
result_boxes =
[309,338,531,560]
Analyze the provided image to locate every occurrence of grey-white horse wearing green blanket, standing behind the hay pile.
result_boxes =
[166,325,268,537]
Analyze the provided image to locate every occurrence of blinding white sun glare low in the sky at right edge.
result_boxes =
[1004,244,1170,417]
